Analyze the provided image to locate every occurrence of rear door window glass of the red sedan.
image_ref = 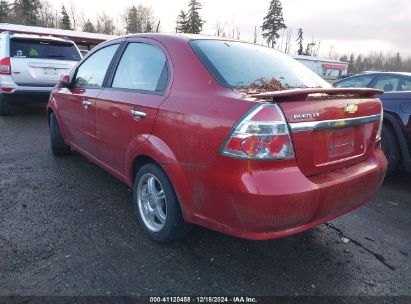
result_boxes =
[112,43,168,93]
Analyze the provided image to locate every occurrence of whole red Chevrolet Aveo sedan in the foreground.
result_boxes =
[47,34,386,242]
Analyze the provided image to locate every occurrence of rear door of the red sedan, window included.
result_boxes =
[96,38,170,176]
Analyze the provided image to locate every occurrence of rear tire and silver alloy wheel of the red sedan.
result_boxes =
[133,163,191,243]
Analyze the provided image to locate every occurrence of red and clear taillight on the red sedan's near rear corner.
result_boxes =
[222,104,294,159]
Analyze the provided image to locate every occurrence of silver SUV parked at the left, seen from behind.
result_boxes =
[0,32,81,115]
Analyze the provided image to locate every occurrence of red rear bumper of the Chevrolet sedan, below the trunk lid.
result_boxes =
[177,147,387,240]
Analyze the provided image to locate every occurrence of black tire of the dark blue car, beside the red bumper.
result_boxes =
[381,124,401,176]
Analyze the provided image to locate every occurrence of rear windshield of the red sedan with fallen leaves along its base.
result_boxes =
[190,40,331,88]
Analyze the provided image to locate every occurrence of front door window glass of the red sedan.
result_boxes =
[74,44,119,88]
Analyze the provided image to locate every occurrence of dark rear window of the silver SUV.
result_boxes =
[10,39,81,61]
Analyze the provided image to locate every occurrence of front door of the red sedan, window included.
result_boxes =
[58,43,119,156]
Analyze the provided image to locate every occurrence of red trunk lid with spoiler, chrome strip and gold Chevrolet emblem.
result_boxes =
[253,88,382,176]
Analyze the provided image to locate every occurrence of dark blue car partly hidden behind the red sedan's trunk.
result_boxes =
[334,72,411,174]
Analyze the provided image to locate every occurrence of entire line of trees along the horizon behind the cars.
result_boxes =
[0,0,411,73]
